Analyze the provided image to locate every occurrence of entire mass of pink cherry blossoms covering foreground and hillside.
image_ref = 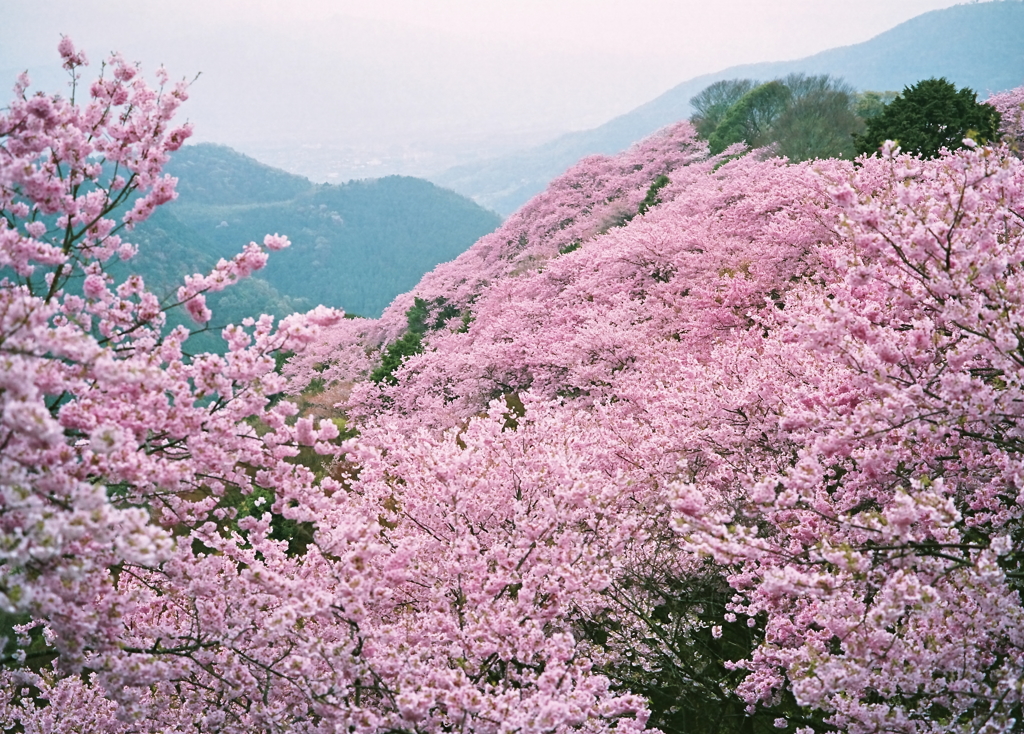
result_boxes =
[6,39,1024,734]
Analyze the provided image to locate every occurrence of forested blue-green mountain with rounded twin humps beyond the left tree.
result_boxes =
[117,143,501,350]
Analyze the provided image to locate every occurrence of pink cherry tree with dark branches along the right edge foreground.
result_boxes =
[676,139,1024,732]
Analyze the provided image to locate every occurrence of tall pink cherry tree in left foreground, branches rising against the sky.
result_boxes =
[0,38,376,731]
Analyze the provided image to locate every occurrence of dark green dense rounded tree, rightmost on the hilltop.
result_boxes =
[855,79,999,158]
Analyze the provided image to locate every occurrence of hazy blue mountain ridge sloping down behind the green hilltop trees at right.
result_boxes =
[430,0,1024,215]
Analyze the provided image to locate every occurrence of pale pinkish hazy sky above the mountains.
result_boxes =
[0,0,970,179]
